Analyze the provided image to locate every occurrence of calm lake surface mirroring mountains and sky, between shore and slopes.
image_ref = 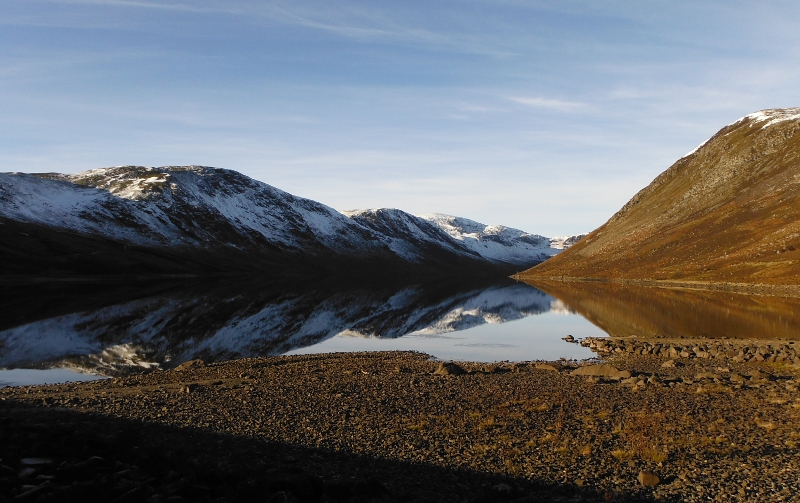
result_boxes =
[0,279,800,386]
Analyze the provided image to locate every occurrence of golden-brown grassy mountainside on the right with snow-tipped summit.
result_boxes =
[519,108,800,285]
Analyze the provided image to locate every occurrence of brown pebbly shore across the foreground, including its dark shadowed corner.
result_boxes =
[0,350,800,503]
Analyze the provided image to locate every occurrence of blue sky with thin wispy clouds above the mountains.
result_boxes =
[0,0,800,236]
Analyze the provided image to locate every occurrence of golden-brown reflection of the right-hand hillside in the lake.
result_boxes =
[531,281,800,339]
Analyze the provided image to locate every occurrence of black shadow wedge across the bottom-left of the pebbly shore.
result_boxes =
[0,400,663,503]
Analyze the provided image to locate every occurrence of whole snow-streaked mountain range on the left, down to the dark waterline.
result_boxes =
[0,166,580,275]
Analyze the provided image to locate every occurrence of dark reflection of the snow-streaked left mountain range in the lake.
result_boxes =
[0,279,563,375]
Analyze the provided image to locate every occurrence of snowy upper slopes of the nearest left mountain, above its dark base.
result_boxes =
[0,166,380,253]
